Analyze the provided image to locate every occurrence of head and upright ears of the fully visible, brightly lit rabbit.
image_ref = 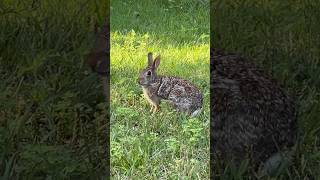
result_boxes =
[138,52,160,86]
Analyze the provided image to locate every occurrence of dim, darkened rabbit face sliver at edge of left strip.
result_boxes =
[86,22,109,102]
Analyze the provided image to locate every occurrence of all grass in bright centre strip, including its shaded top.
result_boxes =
[110,0,210,179]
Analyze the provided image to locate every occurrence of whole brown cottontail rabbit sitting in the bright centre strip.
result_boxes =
[138,53,203,117]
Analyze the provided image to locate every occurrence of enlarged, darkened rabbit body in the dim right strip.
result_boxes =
[211,50,297,175]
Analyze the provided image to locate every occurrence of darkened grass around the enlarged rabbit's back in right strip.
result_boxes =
[210,0,320,179]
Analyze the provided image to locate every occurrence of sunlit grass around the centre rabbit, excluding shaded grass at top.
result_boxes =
[110,25,210,179]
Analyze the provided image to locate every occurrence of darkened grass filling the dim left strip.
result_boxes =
[0,0,108,179]
